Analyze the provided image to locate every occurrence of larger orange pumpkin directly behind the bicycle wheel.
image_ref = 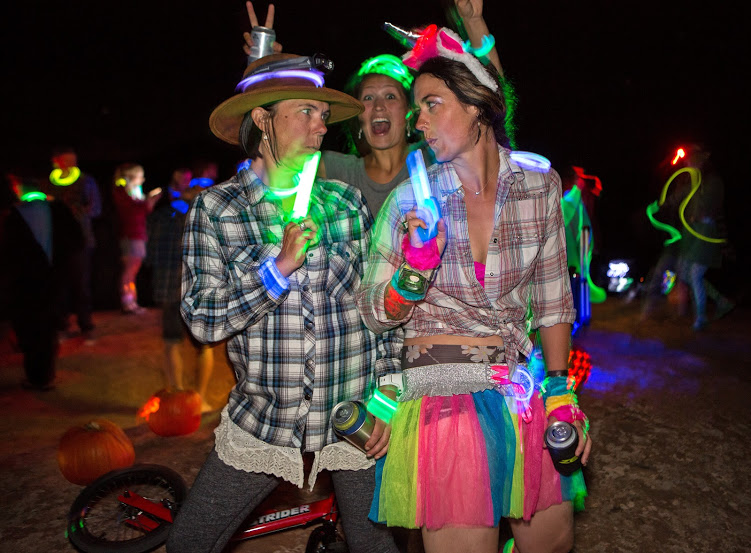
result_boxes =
[57,419,136,486]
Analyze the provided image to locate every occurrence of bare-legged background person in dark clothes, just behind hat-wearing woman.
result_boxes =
[147,168,214,412]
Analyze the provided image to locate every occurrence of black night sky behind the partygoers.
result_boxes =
[0,0,751,306]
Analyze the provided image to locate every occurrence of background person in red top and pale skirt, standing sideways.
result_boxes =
[112,163,162,314]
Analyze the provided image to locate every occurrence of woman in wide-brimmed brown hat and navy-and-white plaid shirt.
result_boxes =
[167,54,400,553]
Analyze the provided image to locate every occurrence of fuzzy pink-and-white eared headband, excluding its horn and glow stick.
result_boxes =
[402,25,499,92]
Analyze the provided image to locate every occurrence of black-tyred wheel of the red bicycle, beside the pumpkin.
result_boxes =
[66,465,187,553]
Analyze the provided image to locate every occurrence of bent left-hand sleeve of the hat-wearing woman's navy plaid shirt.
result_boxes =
[180,195,289,343]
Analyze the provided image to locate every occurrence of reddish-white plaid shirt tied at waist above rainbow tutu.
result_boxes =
[357,148,576,363]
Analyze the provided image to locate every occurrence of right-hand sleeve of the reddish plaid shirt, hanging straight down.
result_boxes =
[531,171,576,330]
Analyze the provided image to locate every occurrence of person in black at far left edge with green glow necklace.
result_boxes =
[0,178,84,391]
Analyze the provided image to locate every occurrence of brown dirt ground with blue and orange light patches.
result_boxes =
[0,298,751,553]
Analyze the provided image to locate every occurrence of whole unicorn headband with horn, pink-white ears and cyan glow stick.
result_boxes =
[386,23,499,92]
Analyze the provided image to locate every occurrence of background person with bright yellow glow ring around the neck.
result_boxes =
[42,146,102,343]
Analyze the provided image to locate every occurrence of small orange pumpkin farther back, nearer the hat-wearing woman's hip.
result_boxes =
[138,390,201,436]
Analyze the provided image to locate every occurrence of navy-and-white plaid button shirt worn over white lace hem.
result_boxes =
[181,169,402,451]
